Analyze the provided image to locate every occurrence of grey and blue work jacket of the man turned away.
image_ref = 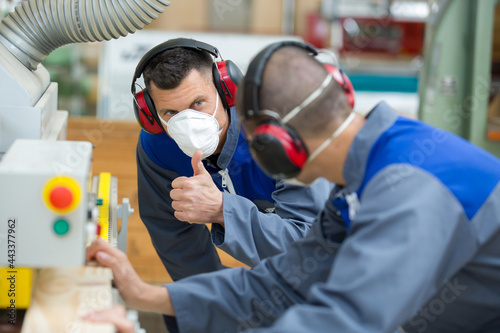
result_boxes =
[166,103,500,333]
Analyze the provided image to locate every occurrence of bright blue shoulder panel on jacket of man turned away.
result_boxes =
[358,117,500,219]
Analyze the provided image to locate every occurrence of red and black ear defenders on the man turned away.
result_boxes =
[242,41,354,180]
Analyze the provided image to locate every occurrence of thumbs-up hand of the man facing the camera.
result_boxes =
[170,150,224,226]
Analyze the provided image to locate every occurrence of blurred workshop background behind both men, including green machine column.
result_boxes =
[0,0,500,332]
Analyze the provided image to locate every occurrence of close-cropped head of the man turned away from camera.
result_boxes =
[237,47,352,137]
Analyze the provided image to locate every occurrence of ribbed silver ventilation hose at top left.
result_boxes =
[0,0,170,70]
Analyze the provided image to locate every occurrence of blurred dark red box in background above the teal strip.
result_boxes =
[340,17,425,55]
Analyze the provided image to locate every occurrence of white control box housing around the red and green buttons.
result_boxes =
[0,140,92,267]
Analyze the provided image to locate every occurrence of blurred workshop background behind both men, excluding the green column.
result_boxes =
[0,0,500,283]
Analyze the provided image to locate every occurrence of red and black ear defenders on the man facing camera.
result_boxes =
[131,38,243,134]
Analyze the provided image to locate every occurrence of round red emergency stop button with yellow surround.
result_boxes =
[43,176,80,214]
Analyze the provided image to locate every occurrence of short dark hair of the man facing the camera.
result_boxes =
[143,47,214,92]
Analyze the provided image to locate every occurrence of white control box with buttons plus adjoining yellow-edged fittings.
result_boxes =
[0,139,131,268]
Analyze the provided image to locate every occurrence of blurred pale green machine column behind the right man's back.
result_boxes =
[419,0,500,157]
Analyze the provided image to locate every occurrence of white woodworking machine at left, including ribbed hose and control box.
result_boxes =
[0,0,169,331]
